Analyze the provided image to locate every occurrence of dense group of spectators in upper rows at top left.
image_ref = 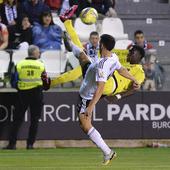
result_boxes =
[0,0,115,51]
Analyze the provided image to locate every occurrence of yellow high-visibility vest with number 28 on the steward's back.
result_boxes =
[16,59,45,90]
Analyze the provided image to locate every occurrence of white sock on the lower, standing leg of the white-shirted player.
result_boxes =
[88,127,111,155]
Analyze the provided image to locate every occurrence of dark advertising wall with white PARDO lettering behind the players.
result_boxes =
[0,92,170,140]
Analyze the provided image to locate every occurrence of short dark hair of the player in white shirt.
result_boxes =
[100,34,115,51]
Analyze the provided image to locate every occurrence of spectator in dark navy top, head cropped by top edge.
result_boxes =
[21,0,50,24]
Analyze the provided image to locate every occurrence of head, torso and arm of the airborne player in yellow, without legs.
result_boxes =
[103,45,145,102]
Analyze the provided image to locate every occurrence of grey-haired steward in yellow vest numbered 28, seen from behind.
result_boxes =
[5,45,50,149]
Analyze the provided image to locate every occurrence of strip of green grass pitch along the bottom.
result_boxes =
[0,148,170,170]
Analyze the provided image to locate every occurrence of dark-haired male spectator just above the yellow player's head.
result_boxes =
[128,30,153,50]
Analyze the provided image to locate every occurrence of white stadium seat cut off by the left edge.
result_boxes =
[0,51,10,79]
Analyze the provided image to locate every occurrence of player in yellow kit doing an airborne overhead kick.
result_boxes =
[51,6,145,102]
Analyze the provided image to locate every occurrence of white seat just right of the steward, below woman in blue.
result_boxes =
[41,50,67,77]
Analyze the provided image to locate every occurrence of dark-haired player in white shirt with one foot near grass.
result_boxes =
[72,34,139,165]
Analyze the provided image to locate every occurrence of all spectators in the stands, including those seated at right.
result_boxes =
[0,0,164,91]
